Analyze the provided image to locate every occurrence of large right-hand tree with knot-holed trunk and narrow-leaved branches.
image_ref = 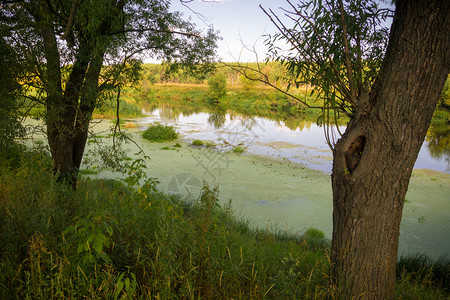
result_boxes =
[265,0,450,299]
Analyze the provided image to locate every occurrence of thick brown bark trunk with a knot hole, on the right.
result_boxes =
[331,0,450,299]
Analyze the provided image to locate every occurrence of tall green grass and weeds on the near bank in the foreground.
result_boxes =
[0,152,449,299]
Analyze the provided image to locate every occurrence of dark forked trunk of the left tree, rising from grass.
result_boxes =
[35,0,105,189]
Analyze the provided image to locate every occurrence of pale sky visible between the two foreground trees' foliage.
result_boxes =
[167,0,286,62]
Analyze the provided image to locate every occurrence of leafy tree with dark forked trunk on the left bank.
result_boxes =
[0,0,217,188]
